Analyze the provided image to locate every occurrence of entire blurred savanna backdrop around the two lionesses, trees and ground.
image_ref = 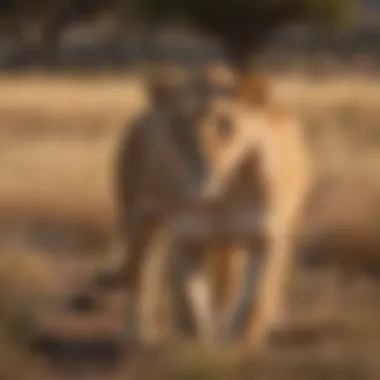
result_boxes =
[0,0,380,380]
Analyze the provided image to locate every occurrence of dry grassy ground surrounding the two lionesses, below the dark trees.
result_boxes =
[0,72,380,380]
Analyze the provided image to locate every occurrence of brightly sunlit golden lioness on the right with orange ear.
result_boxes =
[167,76,312,346]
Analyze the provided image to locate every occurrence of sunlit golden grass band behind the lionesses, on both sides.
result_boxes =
[0,73,380,220]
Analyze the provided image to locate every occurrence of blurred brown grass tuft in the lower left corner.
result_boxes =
[0,248,54,378]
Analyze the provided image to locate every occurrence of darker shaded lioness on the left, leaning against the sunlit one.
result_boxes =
[97,63,249,338]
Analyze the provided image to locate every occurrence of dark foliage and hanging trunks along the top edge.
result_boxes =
[0,0,357,70]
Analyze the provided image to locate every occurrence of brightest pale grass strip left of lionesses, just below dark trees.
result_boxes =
[0,76,142,118]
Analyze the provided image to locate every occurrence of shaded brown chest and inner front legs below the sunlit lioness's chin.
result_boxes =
[169,193,265,342]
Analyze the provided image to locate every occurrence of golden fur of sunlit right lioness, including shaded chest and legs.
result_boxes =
[156,72,311,346]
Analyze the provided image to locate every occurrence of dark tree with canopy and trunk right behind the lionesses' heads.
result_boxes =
[136,0,356,70]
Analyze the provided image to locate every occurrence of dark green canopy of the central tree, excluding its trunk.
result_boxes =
[137,0,356,33]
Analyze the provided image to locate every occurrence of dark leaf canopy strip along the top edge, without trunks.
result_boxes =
[0,0,356,36]
